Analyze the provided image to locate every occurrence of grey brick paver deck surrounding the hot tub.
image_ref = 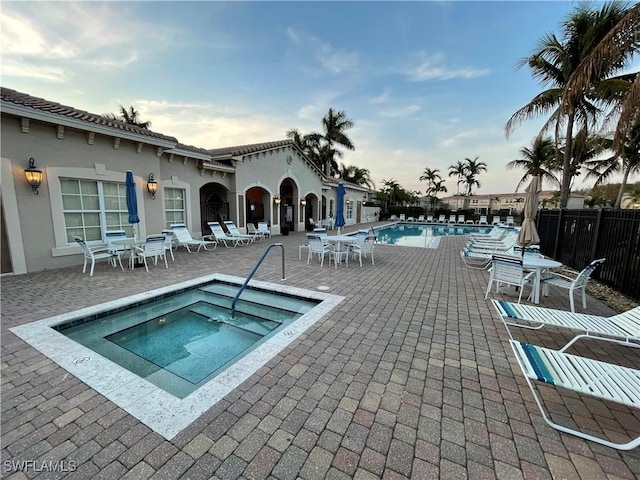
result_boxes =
[1,227,640,480]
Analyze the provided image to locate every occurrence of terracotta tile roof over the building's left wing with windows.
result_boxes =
[0,87,178,142]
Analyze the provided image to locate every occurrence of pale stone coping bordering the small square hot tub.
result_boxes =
[10,273,344,440]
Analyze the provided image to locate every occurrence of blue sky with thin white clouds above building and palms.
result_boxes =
[0,0,632,196]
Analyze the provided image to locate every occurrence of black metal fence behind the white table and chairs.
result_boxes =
[536,209,640,301]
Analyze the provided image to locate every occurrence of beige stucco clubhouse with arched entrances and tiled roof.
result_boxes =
[0,88,377,274]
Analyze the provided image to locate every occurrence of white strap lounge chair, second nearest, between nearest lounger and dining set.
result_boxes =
[491,300,640,350]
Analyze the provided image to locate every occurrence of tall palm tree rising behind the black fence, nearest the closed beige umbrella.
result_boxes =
[505,2,628,208]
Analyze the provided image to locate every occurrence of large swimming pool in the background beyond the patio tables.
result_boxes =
[375,223,493,248]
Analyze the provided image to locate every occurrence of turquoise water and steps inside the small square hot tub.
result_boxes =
[54,282,318,398]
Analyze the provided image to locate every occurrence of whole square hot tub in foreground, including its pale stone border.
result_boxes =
[11,274,343,439]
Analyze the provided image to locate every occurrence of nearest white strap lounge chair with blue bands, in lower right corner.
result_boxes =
[507,338,640,450]
